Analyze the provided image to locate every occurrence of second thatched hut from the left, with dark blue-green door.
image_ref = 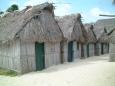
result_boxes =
[57,14,87,61]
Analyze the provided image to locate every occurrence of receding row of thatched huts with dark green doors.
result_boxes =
[0,3,109,73]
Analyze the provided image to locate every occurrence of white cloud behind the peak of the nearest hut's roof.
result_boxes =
[21,0,71,16]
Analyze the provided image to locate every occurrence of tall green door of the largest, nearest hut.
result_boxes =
[35,42,45,70]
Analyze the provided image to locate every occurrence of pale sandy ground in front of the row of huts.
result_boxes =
[0,55,115,86]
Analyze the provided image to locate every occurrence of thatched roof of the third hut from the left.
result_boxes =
[84,24,97,43]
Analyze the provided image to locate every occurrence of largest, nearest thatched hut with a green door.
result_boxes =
[0,3,63,73]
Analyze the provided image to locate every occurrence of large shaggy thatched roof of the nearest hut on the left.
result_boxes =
[0,3,62,42]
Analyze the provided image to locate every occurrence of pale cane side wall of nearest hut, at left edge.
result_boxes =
[0,39,21,73]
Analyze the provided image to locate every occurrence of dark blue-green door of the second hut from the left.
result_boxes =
[68,41,73,62]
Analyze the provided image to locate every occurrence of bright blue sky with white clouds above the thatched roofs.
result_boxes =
[0,0,115,23]
